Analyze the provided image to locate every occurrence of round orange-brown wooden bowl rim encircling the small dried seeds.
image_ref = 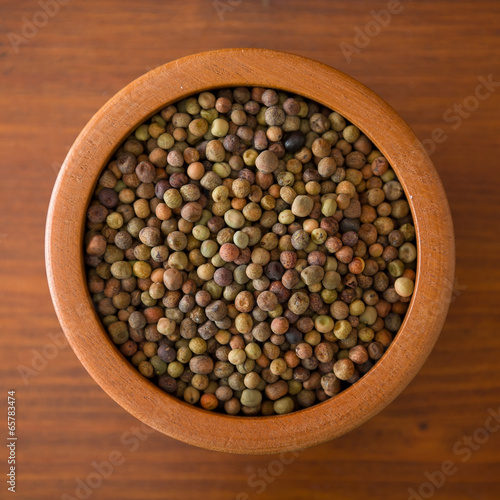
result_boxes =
[46,49,455,454]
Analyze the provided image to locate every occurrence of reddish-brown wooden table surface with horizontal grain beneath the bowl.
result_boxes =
[0,0,500,500]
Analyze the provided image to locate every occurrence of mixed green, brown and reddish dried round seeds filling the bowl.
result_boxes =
[85,88,417,415]
